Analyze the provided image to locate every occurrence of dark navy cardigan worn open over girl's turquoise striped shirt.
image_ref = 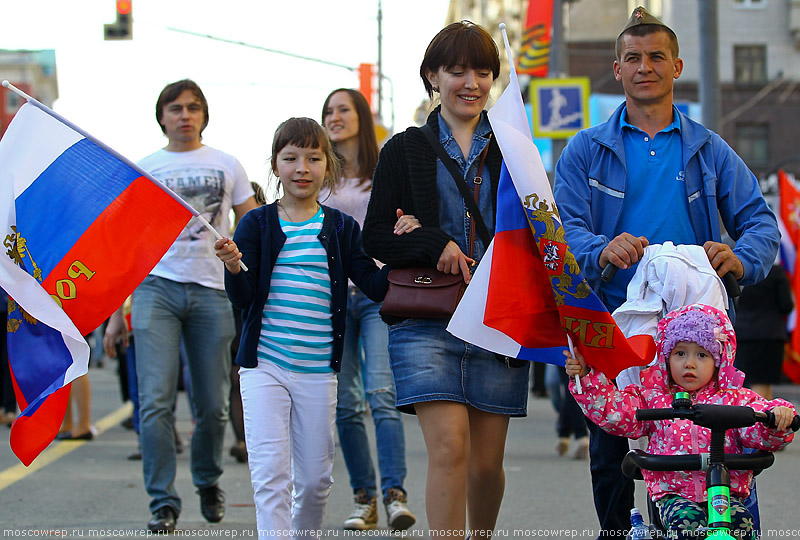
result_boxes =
[225,203,389,371]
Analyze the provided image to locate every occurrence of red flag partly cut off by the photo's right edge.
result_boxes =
[778,170,800,384]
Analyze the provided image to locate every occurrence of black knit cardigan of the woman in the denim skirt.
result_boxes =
[363,107,502,268]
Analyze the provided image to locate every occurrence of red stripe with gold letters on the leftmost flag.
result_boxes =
[42,177,192,335]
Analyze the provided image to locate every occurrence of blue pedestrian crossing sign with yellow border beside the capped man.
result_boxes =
[529,77,589,139]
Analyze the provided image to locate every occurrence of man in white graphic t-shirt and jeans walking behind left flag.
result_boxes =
[107,79,256,532]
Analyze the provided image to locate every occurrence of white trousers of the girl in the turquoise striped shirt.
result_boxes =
[239,361,337,539]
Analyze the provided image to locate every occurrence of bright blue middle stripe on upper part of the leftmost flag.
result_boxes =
[16,139,141,281]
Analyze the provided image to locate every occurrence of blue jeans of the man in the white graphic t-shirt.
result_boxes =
[132,276,234,514]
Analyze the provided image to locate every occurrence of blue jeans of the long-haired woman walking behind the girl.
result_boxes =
[336,287,406,497]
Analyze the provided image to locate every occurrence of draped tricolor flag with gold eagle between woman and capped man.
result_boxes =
[447,35,655,378]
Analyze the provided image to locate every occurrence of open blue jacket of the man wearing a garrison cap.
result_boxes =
[554,103,780,304]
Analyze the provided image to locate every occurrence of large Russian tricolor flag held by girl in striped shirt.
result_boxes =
[0,100,196,465]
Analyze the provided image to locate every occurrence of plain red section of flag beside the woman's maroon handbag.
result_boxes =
[483,229,567,349]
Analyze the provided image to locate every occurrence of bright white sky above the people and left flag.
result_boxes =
[0,0,449,190]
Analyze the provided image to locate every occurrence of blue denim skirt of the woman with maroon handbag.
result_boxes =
[389,319,529,416]
